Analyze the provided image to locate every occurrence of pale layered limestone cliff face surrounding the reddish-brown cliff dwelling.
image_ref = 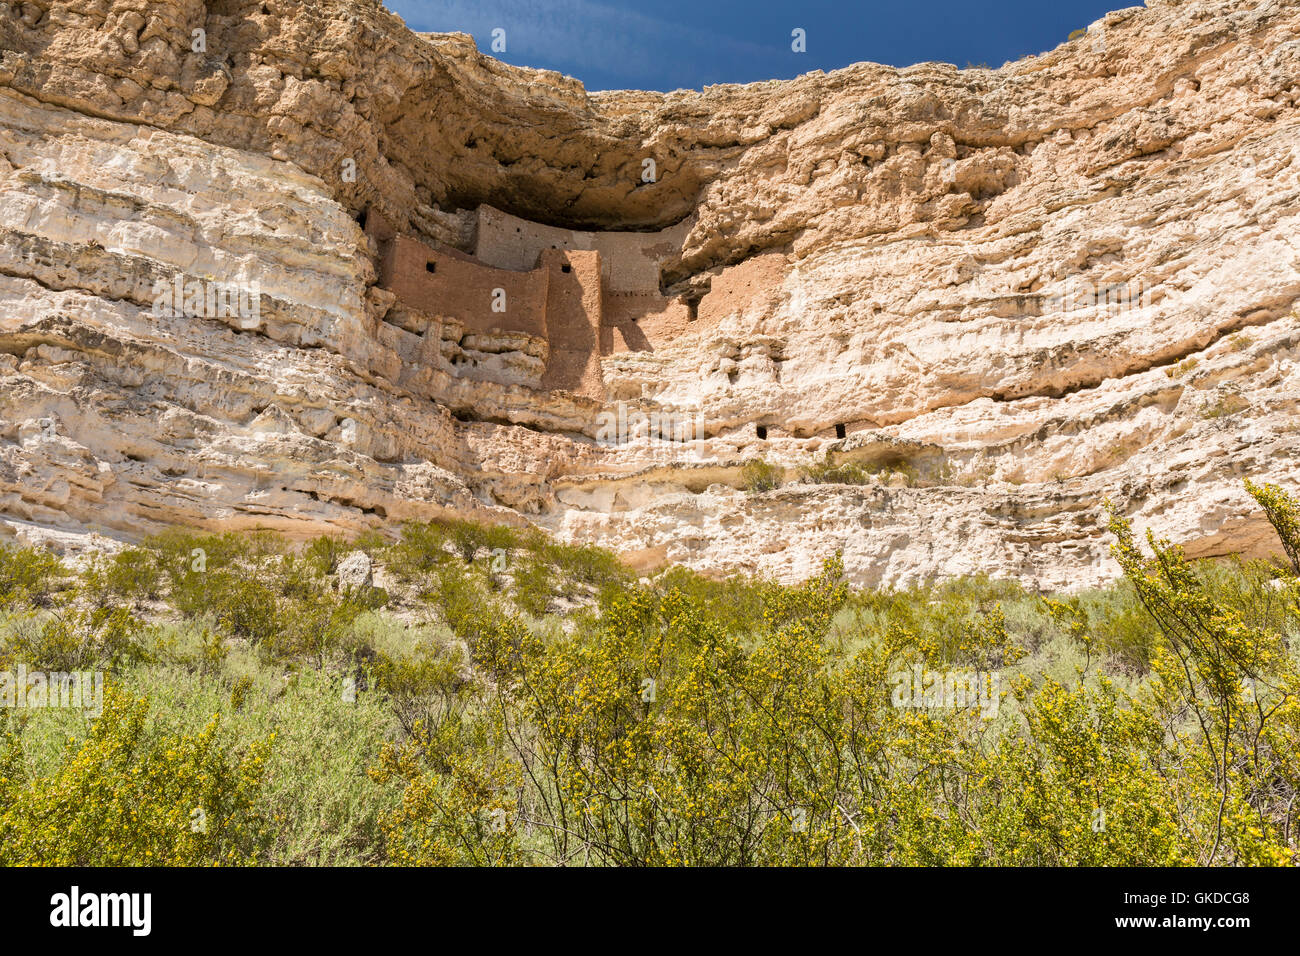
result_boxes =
[0,0,1300,587]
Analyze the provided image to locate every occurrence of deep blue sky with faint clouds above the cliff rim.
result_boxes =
[385,0,1138,90]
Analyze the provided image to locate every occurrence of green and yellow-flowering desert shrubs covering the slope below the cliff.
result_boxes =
[0,484,1300,865]
